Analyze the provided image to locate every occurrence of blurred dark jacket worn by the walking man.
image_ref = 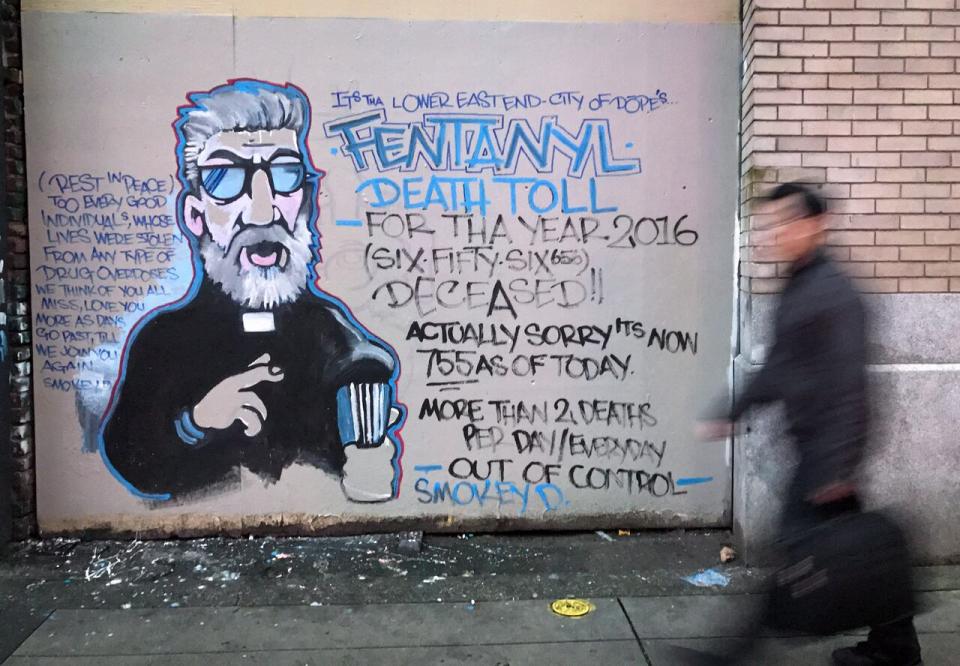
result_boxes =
[730,251,868,508]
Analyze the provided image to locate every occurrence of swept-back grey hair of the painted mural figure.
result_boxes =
[177,81,308,194]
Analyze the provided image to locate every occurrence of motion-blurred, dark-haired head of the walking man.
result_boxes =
[758,183,827,262]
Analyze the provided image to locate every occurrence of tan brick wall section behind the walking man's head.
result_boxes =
[740,0,960,293]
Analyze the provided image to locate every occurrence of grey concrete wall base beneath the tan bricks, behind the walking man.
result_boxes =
[734,294,960,562]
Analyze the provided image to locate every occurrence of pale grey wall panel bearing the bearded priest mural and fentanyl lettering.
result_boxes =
[23,2,738,533]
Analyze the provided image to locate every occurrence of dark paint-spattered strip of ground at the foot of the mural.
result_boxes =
[7,528,752,621]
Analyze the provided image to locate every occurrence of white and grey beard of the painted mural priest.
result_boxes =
[200,219,313,310]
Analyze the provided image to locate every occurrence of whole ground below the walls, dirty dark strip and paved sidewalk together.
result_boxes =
[0,533,960,666]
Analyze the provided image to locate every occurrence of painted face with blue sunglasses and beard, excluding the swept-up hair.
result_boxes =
[184,129,312,309]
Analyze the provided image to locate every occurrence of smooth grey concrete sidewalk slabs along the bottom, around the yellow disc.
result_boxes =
[7,592,960,666]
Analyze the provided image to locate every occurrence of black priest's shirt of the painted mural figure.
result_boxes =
[103,279,394,496]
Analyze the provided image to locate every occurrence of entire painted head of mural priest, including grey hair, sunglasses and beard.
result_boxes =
[174,81,319,309]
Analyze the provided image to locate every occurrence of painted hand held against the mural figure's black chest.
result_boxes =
[192,354,283,437]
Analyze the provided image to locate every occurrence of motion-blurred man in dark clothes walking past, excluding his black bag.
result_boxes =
[700,183,920,666]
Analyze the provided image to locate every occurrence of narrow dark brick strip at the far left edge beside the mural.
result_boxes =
[0,0,36,539]
